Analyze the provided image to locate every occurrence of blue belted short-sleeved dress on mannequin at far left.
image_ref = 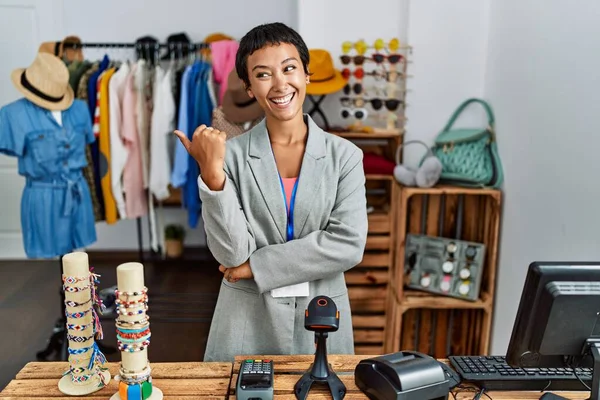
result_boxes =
[0,98,96,258]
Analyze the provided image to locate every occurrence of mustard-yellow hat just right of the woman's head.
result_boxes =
[306,49,347,95]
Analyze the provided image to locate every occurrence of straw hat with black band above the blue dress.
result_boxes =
[10,53,75,111]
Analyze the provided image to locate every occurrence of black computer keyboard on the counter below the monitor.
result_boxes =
[448,356,593,390]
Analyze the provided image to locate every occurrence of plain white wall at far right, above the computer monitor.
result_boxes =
[485,0,600,354]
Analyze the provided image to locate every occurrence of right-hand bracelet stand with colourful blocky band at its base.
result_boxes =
[111,262,163,400]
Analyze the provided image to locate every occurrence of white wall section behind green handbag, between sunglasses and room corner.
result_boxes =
[404,0,491,165]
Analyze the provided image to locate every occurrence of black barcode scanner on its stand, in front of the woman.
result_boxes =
[294,296,346,400]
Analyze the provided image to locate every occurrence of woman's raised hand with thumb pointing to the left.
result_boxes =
[175,124,227,190]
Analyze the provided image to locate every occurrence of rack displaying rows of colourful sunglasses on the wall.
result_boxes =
[340,39,411,134]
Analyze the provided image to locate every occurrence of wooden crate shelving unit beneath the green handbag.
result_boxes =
[384,186,502,358]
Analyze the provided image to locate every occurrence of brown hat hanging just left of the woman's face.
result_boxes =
[221,69,264,124]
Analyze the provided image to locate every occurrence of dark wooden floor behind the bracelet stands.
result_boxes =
[0,252,222,390]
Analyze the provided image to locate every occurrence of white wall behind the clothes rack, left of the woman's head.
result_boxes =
[58,0,298,249]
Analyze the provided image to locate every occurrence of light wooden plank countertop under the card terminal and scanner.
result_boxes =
[0,355,589,400]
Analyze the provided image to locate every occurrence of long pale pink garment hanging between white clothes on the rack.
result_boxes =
[121,64,148,218]
